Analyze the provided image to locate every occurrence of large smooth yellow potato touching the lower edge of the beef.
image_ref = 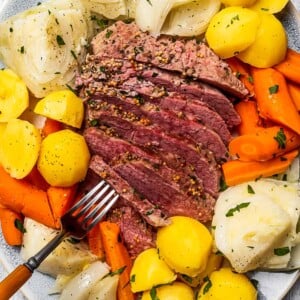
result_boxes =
[156,216,212,277]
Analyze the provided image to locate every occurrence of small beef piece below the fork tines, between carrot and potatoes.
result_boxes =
[108,206,155,259]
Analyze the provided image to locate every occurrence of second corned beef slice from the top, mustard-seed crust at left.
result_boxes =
[76,55,240,129]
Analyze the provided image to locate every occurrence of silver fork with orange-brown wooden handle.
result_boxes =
[0,180,119,300]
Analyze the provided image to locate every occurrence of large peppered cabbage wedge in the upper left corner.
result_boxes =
[0,0,92,98]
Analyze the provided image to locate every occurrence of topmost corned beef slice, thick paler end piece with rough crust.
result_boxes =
[92,21,248,97]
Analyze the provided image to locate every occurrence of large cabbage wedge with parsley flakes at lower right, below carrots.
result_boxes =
[213,179,300,273]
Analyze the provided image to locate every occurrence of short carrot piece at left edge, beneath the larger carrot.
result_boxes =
[0,206,24,246]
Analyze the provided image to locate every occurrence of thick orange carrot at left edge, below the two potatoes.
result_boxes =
[0,166,55,228]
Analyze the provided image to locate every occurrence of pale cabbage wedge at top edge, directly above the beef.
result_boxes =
[135,0,220,36]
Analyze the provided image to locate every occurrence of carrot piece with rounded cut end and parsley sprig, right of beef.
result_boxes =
[229,126,300,161]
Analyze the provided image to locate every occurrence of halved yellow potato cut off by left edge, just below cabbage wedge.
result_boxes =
[0,69,29,122]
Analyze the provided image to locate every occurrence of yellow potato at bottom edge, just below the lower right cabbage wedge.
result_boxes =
[198,268,257,300]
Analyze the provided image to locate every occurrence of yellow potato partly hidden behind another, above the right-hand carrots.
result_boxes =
[238,14,287,68]
